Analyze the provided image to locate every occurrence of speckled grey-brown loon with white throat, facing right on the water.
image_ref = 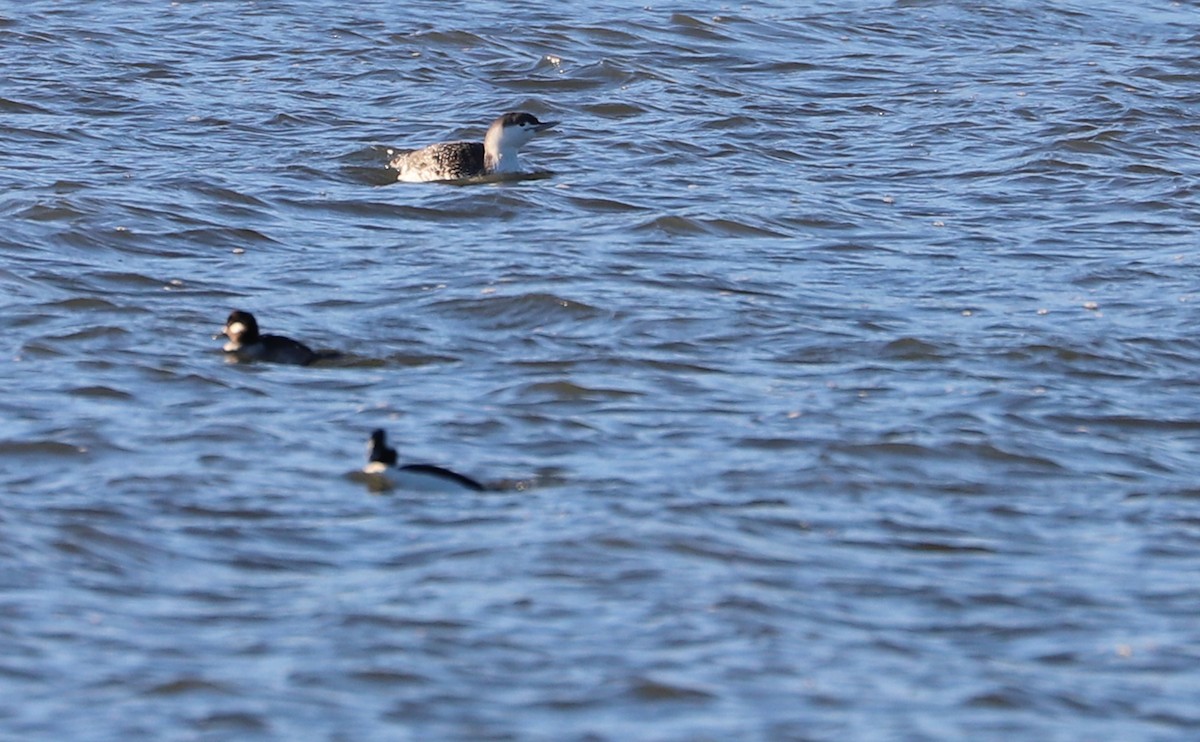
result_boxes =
[389,112,558,182]
